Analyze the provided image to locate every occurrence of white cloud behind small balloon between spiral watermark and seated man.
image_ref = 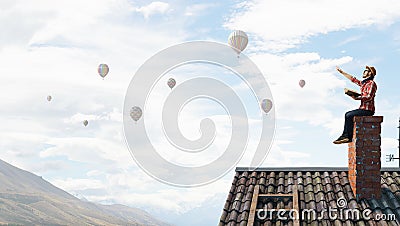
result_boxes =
[252,53,352,128]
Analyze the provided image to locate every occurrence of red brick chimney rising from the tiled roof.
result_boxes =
[348,116,383,200]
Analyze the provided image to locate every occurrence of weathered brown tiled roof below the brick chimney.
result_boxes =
[219,167,400,226]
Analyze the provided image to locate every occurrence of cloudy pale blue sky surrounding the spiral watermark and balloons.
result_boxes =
[0,0,400,225]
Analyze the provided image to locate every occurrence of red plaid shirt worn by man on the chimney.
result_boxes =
[351,77,378,112]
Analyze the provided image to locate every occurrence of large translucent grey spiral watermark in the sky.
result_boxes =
[123,41,275,187]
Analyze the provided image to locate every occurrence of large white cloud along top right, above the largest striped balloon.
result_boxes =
[225,0,400,52]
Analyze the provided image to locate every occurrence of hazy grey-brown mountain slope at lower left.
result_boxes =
[0,160,169,226]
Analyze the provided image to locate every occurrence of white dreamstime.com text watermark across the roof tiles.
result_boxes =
[256,197,396,221]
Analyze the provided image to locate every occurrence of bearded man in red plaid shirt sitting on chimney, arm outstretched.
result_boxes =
[333,66,377,144]
